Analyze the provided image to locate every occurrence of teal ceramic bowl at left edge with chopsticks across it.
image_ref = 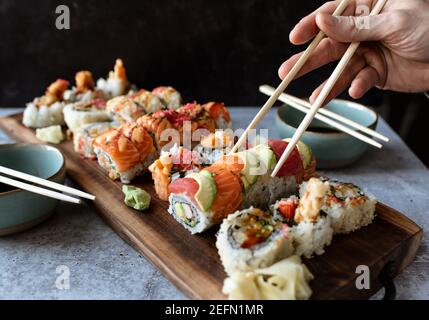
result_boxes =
[0,144,66,235]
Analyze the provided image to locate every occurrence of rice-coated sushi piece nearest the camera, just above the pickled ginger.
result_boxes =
[216,207,294,275]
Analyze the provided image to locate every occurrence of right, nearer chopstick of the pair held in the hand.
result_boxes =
[271,0,387,177]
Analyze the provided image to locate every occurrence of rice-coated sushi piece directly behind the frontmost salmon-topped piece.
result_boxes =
[73,122,117,159]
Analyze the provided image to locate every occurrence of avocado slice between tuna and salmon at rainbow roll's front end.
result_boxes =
[188,170,216,212]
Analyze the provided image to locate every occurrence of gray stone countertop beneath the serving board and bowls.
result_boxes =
[0,107,429,299]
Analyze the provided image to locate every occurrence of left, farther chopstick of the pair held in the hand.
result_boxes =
[230,0,351,153]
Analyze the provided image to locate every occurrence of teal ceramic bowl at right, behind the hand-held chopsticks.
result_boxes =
[276,99,378,169]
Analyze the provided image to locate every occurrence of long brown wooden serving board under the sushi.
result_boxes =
[0,115,423,299]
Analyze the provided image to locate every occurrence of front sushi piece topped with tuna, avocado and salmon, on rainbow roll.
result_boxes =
[168,166,242,234]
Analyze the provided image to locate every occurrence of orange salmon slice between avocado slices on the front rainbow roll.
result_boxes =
[205,166,243,222]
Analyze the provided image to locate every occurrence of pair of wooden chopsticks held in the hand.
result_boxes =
[231,0,387,177]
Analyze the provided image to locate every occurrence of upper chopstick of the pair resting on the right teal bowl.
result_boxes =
[259,85,390,142]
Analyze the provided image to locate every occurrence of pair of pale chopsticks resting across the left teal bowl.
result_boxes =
[0,166,95,204]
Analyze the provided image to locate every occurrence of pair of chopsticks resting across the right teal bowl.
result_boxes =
[259,85,389,148]
